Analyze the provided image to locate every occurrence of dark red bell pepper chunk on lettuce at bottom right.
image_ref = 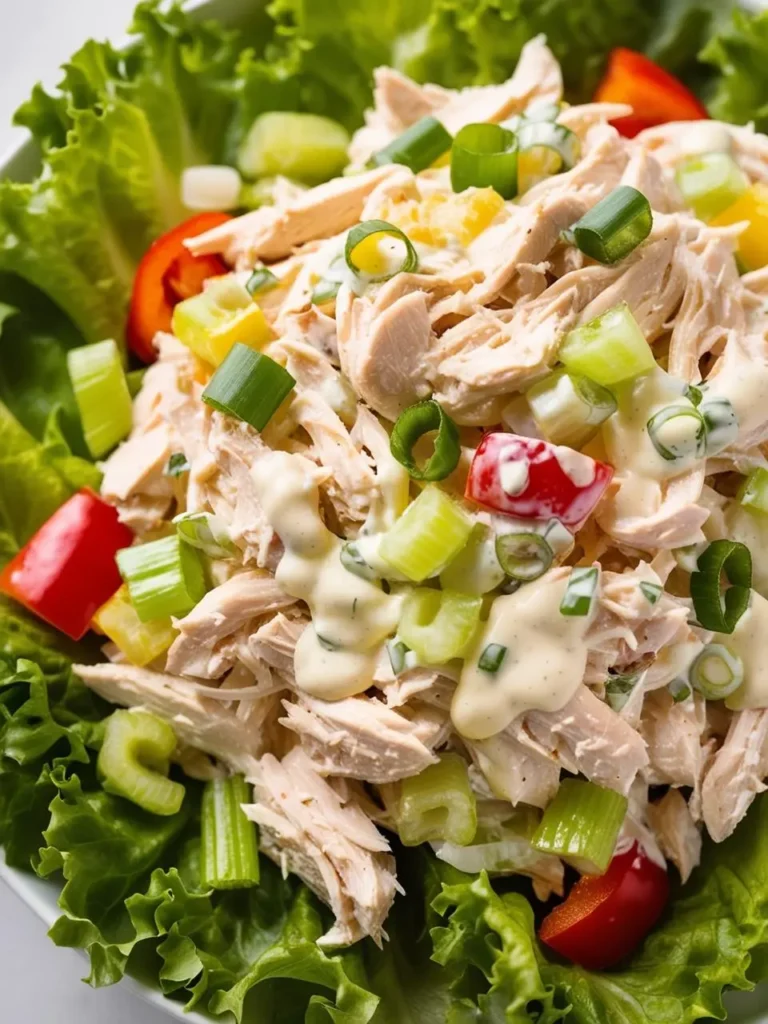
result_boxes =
[539,843,670,971]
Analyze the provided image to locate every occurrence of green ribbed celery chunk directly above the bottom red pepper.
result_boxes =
[532,778,627,874]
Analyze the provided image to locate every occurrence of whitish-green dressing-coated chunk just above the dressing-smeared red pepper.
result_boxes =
[525,370,616,449]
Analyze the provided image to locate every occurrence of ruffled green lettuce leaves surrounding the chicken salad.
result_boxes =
[0,0,768,1024]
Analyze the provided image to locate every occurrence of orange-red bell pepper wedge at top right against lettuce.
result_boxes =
[595,47,710,138]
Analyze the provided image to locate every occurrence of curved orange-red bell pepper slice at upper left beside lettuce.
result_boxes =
[126,213,231,362]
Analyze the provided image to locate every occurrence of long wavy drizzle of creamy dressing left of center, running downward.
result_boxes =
[251,452,401,700]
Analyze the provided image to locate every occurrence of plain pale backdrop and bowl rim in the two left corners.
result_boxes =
[0,6,170,1024]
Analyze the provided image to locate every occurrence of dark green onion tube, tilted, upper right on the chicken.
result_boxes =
[568,185,653,266]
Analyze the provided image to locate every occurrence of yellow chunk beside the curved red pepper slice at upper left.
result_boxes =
[172,273,271,367]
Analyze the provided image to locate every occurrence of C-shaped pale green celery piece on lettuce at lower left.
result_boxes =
[96,711,186,816]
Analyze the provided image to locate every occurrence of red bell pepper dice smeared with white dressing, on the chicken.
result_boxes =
[466,433,613,530]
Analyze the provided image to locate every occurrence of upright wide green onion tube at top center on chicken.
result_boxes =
[451,124,517,199]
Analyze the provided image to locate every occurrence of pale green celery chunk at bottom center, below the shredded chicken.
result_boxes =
[396,754,477,846]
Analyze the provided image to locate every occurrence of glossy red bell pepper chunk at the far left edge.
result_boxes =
[0,489,133,640]
